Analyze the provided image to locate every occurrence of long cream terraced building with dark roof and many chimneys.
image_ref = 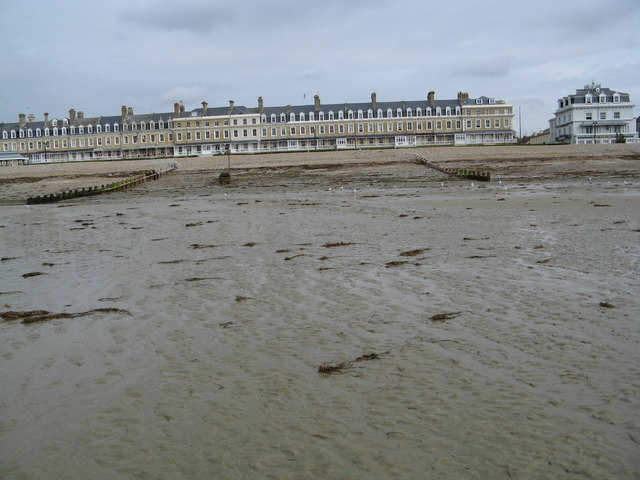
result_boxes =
[0,92,516,163]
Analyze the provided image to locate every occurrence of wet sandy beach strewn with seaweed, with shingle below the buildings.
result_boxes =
[0,145,640,480]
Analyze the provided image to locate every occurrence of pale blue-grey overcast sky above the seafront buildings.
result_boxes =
[0,0,640,134]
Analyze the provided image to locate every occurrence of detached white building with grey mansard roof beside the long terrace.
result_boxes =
[549,83,638,144]
